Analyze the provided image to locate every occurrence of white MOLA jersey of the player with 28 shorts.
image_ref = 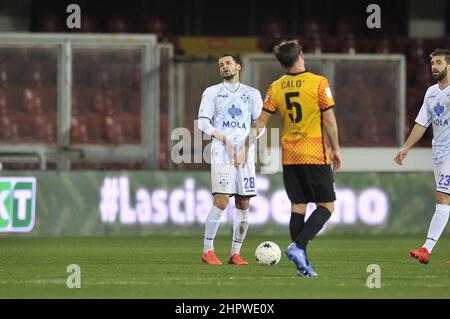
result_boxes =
[198,82,263,162]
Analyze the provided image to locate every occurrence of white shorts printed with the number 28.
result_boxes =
[211,161,256,196]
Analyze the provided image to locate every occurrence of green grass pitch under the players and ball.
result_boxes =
[0,235,450,299]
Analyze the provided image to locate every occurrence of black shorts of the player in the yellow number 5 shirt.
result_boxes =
[283,164,336,204]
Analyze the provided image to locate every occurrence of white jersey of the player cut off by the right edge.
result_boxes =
[416,84,450,164]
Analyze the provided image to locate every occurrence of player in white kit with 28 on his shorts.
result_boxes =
[198,54,263,265]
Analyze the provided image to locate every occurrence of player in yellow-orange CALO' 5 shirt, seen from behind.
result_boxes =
[238,41,341,277]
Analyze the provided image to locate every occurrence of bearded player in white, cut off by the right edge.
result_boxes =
[394,49,450,264]
